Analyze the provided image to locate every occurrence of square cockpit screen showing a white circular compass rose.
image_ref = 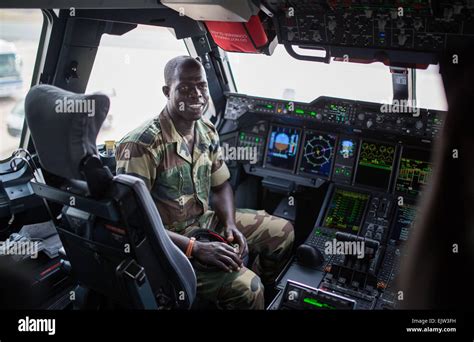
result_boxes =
[299,131,336,177]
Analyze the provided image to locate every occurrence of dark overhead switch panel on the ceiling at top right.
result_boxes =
[267,0,474,65]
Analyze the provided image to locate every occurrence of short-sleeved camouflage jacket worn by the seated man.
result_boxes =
[116,109,230,233]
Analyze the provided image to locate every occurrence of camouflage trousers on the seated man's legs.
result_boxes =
[184,209,294,309]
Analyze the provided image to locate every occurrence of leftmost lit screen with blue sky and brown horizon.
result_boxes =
[265,125,301,172]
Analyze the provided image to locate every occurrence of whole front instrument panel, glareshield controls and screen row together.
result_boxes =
[221,94,438,198]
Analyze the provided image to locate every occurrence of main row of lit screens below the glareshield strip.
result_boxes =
[233,124,432,202]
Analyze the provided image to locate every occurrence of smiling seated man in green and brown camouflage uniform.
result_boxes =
[116,56,294,309]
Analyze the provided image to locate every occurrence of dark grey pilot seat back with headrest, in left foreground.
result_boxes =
[25,85,196,309]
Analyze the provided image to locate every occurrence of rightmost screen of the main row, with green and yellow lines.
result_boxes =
[395,148,432,197]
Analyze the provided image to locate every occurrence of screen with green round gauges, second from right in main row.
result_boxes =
[355,141,395,190]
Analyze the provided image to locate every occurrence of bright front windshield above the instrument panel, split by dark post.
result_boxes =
[227,45,447,110]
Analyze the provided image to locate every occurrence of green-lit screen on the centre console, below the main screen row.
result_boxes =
[323,188,369,234]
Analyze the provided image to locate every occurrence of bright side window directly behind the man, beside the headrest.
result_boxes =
[86,25,189,144]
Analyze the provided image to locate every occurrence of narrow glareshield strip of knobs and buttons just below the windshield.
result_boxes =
[224,93,445,141]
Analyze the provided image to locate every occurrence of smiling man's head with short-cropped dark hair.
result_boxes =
[163,61,209,121]
